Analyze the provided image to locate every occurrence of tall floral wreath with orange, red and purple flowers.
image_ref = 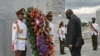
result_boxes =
[25,7,54,56]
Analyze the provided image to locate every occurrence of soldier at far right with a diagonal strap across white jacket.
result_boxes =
[90,17,99,50]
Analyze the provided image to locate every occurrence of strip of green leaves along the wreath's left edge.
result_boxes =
[25,7,39,56]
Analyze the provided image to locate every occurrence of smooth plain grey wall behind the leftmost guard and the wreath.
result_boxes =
[0,0,46,56]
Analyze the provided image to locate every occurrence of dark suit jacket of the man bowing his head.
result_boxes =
[67,15,84,47]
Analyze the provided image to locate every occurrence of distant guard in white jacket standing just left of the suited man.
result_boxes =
[58,21,66,54]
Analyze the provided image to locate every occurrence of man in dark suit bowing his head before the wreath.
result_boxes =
[66,9,84,56]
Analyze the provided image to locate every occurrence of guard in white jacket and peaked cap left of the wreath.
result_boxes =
[12,8,27,56]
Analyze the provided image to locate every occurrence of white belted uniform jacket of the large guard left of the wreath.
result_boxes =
[12,20,27,50]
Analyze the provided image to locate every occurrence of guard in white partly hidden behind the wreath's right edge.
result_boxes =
[46,11,56,56]
